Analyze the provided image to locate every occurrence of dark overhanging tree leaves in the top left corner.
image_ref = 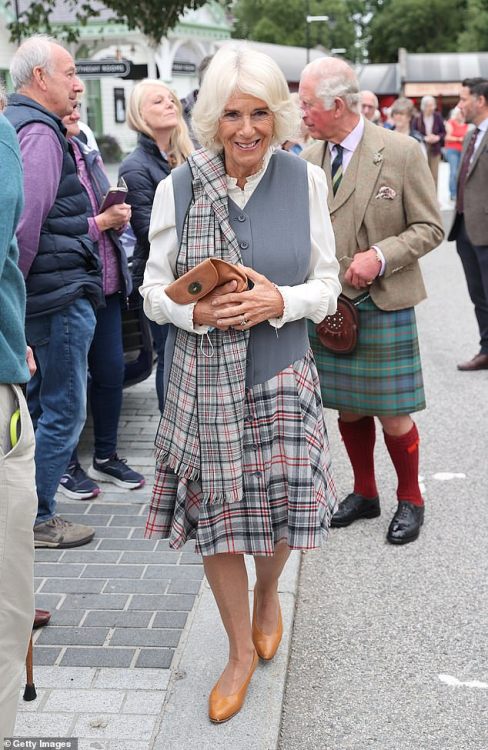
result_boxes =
[9,0,226,45]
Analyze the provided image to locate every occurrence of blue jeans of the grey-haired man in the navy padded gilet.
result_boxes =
[26,298,95,523]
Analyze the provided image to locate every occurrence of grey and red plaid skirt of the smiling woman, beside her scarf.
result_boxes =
[146,351,336,555]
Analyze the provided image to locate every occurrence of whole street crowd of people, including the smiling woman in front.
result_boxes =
[0,35,488,740]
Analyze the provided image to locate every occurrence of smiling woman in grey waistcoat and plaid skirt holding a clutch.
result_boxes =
[141,45,340,723]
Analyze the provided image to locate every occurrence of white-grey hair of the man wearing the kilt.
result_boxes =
[305,57,361,114]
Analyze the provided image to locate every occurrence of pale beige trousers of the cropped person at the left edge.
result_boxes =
[0,383,37,748]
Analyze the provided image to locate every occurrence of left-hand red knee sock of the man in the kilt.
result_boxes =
[338,417,378,500]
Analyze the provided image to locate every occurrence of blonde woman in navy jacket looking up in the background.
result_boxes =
[119,78,193,412]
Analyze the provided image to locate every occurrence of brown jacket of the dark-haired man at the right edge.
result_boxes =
[448,131,488,245]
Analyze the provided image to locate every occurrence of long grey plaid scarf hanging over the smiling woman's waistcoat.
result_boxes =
[156,149,249,504]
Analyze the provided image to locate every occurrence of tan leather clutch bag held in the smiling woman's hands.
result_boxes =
[164,258,248,305]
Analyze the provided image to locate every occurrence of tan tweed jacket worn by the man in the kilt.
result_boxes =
[301,120,444,310]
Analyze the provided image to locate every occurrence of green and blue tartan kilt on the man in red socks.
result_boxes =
[308,298,425,416]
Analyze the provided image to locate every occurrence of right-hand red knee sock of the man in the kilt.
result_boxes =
[383,423,424,505]
